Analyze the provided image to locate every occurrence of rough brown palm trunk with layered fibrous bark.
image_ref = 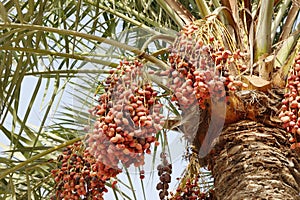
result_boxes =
[210,120,300,200]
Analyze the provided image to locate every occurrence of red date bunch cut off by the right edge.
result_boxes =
[279,52,300,149]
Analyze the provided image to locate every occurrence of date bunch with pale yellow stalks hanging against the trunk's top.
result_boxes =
[165,22,247,109]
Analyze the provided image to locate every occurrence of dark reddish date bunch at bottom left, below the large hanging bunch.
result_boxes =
[51,141,120,200]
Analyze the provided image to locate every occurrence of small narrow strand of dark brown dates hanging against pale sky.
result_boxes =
[156,152,172,199]
